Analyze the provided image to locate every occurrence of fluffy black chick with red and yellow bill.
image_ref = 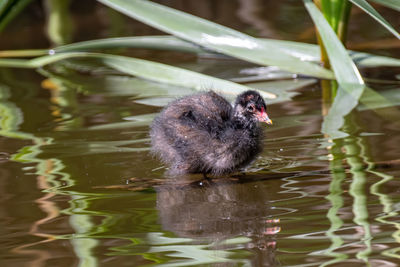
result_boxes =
[150,90,272,178]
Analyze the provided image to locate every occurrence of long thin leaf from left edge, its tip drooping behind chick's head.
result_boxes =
[0,52,276,98]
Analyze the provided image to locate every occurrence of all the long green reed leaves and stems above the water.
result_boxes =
[0,0,400,138]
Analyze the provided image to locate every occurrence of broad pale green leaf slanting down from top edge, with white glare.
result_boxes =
[98,0,333,79]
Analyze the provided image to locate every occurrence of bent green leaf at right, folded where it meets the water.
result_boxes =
[303,0,365,138]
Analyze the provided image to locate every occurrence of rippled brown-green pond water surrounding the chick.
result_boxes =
[0,1,400,266]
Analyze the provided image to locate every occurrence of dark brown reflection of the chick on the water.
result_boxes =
[157,180,280,265]
